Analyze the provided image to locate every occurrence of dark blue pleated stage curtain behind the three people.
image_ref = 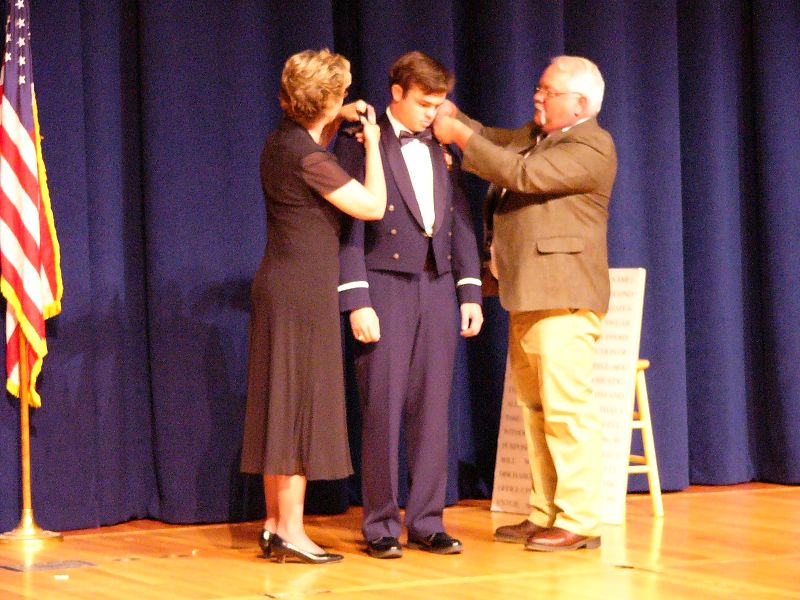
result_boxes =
[0,0,800,530]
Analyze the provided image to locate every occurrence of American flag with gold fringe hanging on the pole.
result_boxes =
[0,0,62,406]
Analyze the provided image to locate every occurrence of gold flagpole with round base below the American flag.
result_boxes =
[0,332,64,544]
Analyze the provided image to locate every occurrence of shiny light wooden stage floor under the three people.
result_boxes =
[0,484,800,600]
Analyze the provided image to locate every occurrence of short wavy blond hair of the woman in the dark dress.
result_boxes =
[278,48,351,125]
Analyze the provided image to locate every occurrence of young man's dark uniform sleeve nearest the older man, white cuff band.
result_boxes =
[449,152,482,304]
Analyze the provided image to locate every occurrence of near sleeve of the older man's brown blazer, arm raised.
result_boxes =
[463,126,614,196]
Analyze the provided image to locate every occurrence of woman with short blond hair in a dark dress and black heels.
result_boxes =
[242,50,386,563]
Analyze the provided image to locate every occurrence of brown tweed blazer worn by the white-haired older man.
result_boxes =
[459,115,617,313]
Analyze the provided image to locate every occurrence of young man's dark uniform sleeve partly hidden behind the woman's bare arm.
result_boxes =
[333,133,372,312]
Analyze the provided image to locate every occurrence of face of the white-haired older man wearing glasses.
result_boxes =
[533,65,586,133]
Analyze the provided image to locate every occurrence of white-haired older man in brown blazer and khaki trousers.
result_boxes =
[434,56,617,551]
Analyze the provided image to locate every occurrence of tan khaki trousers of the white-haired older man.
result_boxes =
[509,309,602,536]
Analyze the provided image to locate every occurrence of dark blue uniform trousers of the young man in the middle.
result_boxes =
[355,261,459,541]
